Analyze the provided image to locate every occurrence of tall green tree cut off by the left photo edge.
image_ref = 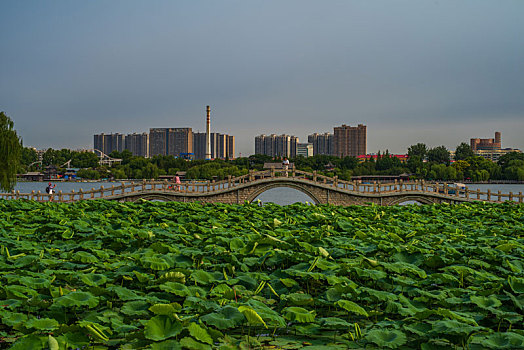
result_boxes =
[0,112,23,191]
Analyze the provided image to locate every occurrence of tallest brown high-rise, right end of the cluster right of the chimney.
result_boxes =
[333,124,367,158]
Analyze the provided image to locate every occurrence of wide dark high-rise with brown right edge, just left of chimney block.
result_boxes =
[149,128,193,157]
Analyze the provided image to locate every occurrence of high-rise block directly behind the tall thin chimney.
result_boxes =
[193,132,235,159]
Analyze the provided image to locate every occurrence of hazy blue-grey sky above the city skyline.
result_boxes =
[0,0,524,156]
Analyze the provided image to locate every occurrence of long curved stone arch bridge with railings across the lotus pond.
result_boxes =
[0,169,523,205]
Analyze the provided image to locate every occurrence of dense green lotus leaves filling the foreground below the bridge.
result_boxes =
[0,201,524,349]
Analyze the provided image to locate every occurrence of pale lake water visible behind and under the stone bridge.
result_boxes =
[4,182,524,205]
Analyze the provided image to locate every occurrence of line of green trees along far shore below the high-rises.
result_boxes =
[21,143,524,181]
